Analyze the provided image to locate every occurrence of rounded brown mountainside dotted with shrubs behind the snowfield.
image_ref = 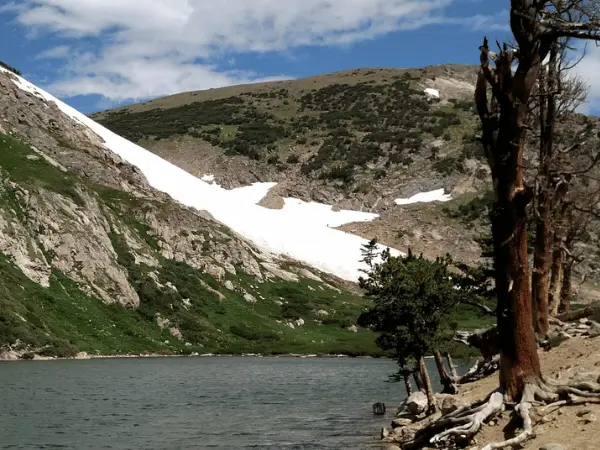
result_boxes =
[92,65,600,298]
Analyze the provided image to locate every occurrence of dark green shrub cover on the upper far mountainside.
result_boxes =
[97,72,475,189]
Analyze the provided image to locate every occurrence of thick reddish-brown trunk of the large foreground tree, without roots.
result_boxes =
[475,39,542,401]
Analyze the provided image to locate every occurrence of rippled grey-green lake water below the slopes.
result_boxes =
[0,357,434,450]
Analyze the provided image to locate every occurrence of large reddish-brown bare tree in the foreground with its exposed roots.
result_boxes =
[405,0,600,450]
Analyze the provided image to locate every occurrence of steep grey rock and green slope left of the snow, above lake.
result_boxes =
[0,69,394,359]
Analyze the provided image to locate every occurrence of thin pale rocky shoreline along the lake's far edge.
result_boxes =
[0,350,393,363]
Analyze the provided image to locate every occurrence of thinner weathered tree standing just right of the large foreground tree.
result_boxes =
[530,34,587,337]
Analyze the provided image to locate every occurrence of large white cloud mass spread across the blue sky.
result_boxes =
[15,0,502,101]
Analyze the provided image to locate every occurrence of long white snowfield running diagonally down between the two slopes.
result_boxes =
[0,67,406,281]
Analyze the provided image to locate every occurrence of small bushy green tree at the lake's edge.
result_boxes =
[359,248,459,413]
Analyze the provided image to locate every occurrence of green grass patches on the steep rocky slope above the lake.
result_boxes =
[0,135,490,356]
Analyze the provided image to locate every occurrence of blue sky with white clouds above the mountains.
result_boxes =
[0,0,600,114]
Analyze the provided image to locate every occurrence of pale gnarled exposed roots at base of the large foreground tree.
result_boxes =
[401,374,600,450]
